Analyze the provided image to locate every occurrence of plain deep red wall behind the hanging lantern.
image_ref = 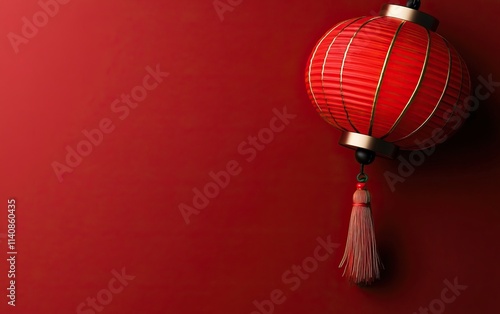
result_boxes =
[0,0,500,314]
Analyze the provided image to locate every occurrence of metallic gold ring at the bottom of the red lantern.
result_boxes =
[339,132,398,159]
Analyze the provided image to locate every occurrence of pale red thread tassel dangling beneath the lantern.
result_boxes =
[339,183,382,285]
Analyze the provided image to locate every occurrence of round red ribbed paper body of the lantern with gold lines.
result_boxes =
[306,16,470,150]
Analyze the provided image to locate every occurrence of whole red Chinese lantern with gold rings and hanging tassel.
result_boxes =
[306,1,470,284]
